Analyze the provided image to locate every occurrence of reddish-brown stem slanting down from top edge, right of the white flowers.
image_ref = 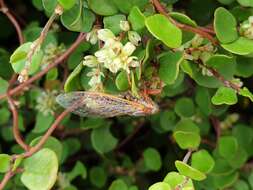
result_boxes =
[151,0,218,45]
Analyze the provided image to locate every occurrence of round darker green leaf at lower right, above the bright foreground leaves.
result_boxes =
[218,136,238,159]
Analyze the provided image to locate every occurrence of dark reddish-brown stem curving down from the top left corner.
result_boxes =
[0,0,24,44]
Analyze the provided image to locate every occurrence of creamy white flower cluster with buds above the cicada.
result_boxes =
[83,24,141,90]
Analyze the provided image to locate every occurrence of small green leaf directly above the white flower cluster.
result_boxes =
[103,14,126,35]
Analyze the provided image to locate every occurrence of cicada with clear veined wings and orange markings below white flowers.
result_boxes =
[56,91,159,118]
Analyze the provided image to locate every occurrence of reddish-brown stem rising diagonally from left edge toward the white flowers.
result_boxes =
[0,33,86,100]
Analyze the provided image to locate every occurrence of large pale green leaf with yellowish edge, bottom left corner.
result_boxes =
[21,148,58,190]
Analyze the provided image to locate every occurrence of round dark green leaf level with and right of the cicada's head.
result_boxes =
[175,97,195,117]
